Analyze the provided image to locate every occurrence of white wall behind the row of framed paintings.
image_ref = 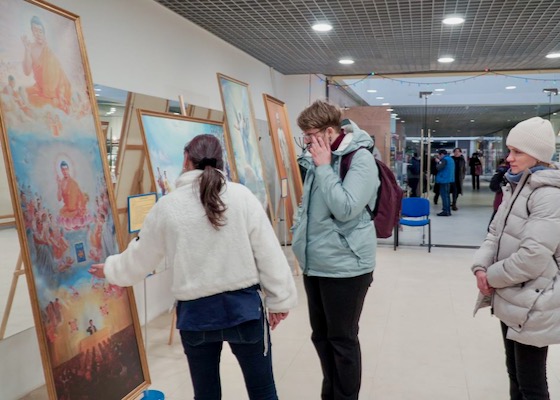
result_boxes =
[0,0,325,400]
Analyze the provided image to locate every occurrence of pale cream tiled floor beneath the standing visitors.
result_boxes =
[17,189,560,400]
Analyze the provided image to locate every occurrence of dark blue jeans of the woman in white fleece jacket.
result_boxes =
[180,317,278,400]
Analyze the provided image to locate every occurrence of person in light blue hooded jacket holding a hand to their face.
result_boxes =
[292,101,379,400]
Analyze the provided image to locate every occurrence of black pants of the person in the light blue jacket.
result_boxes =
[303,272,373,400]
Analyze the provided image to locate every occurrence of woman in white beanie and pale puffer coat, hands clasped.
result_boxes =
[471,117,560,400]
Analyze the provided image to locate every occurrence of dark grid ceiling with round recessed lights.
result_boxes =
[156,0,560,75]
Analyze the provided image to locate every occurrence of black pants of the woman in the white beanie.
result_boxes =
[500,322,550,400]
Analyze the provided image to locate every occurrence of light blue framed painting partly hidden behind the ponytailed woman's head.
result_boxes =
[137,110,236,197]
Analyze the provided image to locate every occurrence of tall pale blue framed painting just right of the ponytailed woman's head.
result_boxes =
[218,74,273,217]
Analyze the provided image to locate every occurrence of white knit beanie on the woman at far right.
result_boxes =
[506,117,556,162]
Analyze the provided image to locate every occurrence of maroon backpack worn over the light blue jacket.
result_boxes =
[340,147,403,238]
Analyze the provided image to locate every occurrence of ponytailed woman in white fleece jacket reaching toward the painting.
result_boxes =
[90,135,297,400]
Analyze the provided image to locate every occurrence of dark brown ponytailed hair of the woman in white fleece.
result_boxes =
[184,135,227,230]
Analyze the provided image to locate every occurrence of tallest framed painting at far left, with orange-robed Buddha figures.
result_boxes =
[0,0,149,400]
